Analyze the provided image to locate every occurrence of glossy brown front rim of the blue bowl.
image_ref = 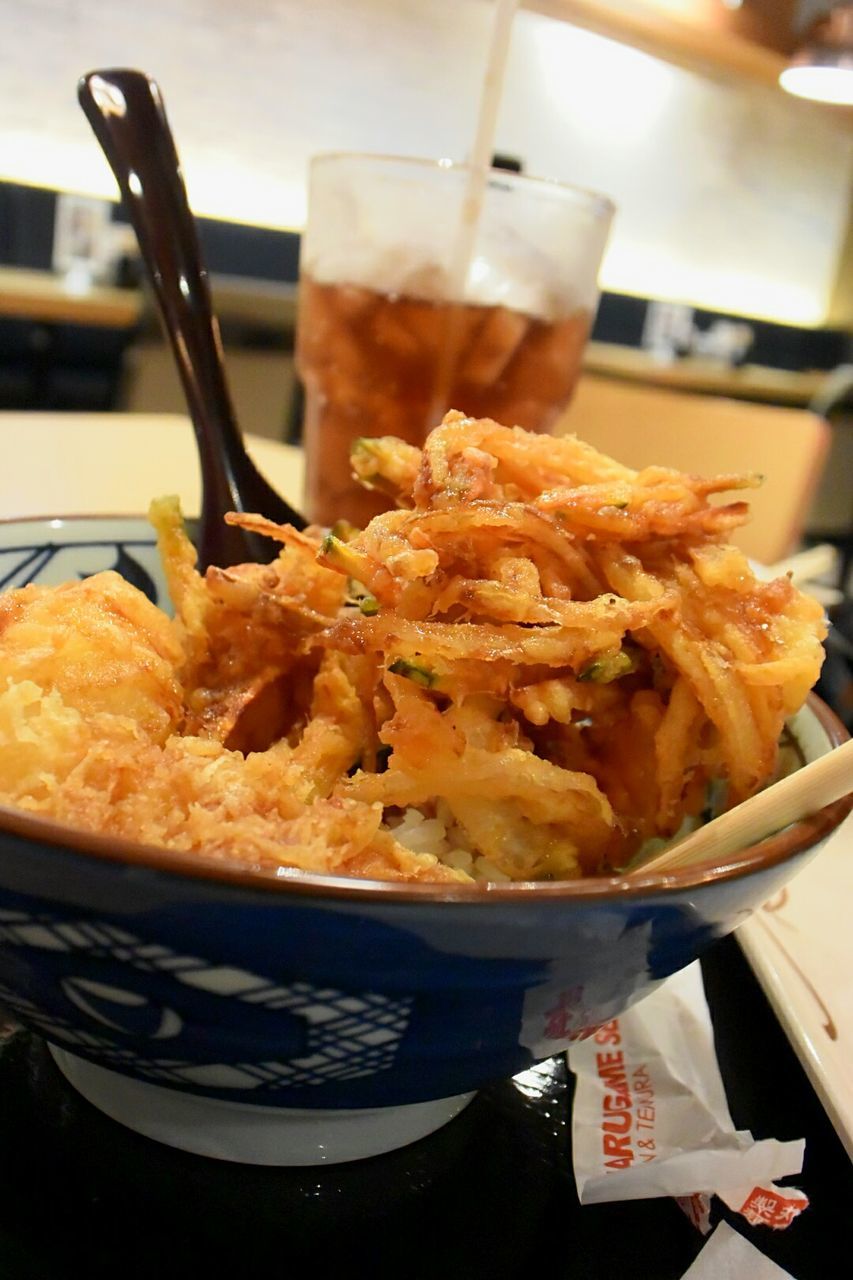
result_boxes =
[0,694,853,906]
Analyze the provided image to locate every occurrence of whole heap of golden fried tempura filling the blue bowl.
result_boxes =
[0,413,825,881]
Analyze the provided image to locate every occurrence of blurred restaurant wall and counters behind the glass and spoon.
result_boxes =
[0,0,853,585]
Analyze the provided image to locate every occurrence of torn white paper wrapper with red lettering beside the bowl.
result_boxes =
[569,964,808,1231]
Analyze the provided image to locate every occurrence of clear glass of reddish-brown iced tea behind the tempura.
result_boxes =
[297,155,613,525]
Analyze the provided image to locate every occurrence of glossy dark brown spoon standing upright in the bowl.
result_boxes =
[77,69,306,568]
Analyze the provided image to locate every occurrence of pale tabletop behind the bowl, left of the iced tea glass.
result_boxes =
[0,412,302,518]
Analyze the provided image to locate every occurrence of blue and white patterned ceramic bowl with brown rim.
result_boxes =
[0,518,850,1165]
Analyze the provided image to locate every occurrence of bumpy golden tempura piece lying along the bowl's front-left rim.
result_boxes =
[0,681,461,882]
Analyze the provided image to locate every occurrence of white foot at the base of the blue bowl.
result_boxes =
[49,1044,474,1166]
